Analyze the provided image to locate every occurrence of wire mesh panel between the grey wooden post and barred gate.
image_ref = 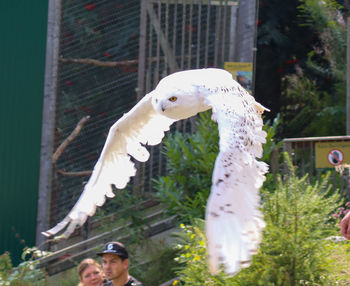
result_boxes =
[51,1,140,227]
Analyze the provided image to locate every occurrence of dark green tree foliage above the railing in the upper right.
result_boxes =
[282,0,346,137]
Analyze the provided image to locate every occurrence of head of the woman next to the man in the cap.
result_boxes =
[78,258,103,286]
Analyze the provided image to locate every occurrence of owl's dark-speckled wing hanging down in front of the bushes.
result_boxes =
[206,81,268,275]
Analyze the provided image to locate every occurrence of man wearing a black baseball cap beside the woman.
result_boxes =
[97,241,144,286]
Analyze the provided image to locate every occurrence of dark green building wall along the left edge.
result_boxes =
[0,0,47,263]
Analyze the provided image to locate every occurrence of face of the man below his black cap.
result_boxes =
[102,253,129,280]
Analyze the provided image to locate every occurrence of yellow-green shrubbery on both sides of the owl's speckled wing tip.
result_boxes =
[177,155,339,286]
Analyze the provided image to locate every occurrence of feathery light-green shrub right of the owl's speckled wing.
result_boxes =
[238,155,340,285]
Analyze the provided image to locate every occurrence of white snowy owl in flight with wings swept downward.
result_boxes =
[43,68,268,275]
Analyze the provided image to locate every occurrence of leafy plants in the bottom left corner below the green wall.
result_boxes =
[0,247,48,286]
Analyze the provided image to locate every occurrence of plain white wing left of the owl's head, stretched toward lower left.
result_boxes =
[43,93,175,237]
